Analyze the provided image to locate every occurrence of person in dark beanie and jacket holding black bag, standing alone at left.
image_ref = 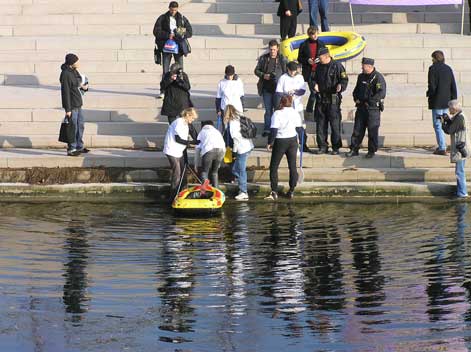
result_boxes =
[59,53,89,156]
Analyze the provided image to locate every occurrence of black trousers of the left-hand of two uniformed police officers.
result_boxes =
[315,101,342,150]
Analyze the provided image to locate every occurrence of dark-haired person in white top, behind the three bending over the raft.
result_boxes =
[216,65,244,117]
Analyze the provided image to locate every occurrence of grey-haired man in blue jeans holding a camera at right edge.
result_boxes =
[440,100,471,198]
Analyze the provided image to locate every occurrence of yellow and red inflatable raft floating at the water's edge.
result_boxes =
[172,180,226,214]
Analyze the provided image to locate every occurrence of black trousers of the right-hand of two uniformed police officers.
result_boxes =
[350,107,381,153]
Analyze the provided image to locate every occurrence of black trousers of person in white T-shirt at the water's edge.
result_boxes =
[270,137,298,192]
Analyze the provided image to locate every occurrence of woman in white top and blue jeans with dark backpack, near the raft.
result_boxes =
[224,105,254,200]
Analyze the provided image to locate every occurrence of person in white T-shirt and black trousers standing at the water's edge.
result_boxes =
[265,95,304,200]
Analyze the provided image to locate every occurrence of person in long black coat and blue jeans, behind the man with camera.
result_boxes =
[427,50,457,155]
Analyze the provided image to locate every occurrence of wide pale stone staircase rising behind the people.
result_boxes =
[0,0,471,148]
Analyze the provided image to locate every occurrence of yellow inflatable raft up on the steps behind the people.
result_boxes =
[281,32,366,61]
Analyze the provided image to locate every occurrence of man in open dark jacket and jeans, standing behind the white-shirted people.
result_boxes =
[254,40,288,137]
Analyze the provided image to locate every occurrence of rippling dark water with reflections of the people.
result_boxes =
[0,203,471,352]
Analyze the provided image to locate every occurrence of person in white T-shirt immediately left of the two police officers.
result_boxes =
[276,61,310,152]
